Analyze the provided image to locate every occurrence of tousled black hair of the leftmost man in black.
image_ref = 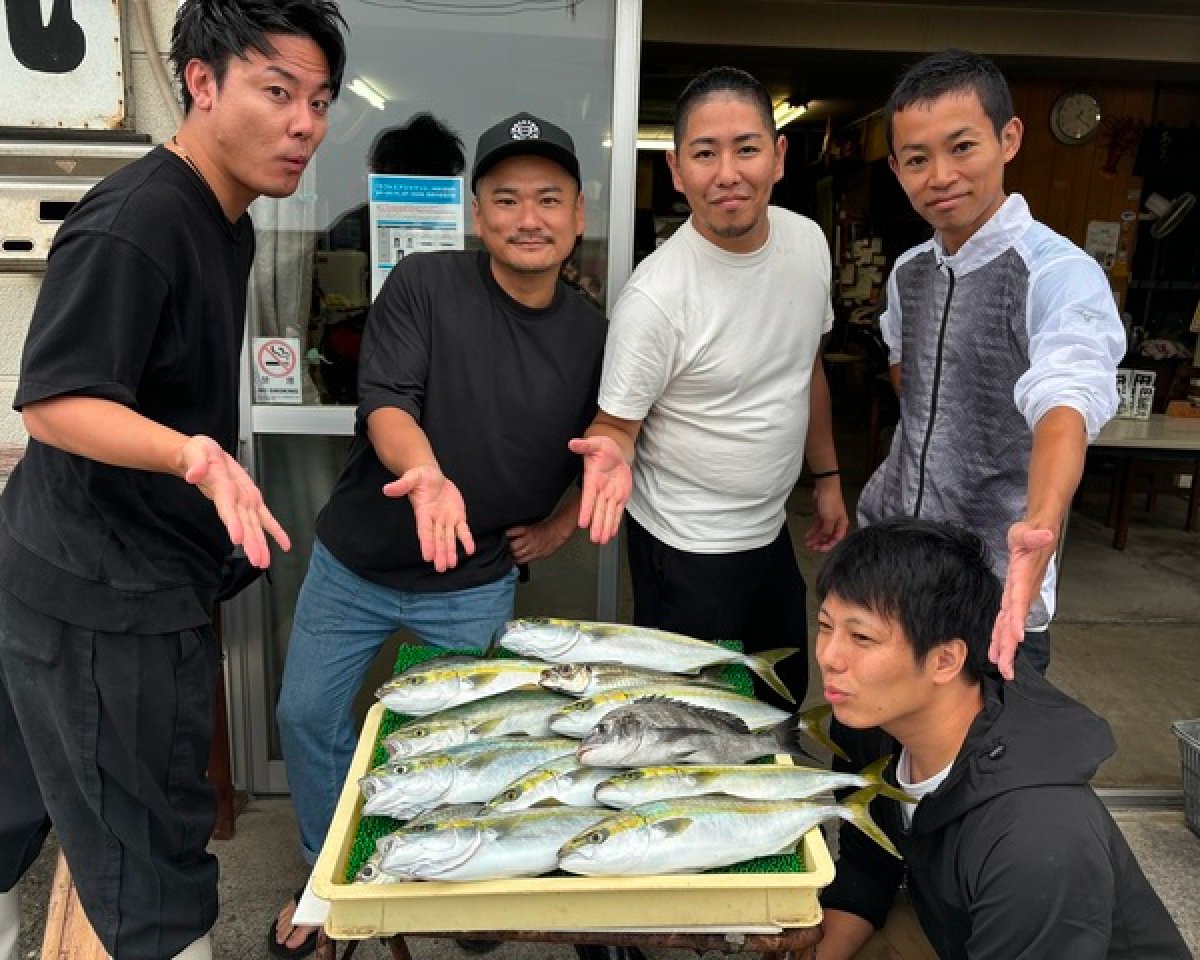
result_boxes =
[170,0,346,113]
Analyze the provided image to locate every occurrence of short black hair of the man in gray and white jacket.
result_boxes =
[883,47,1016,156]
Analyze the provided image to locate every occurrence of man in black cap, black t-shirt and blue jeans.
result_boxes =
[269,114,605,956]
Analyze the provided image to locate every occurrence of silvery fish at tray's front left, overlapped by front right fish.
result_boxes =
[377,806,612,881]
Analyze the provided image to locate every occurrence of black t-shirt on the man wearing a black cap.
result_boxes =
[317,252,605,593]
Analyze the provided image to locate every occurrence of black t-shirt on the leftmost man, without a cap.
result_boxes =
[0,146,254,634]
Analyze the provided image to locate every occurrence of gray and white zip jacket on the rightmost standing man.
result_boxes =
[858,193,1126,630]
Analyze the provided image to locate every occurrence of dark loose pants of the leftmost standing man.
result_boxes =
[0,590,218,960]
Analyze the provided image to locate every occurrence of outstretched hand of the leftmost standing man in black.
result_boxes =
[182,434,292,569]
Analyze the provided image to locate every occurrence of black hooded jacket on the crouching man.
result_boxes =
[821,659,1192,960]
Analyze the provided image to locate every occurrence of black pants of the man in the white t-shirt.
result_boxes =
[625,515,809,709]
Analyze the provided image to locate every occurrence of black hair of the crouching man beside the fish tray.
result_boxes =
[817,517,1003,683]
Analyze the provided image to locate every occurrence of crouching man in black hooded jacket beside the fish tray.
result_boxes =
[816,518,1192,960]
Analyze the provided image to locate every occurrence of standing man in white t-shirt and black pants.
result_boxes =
[572,67,848,701]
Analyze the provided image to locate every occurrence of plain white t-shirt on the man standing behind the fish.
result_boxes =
[600,206,833,553]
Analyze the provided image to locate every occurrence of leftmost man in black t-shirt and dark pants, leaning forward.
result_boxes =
[0,7,346,960]
